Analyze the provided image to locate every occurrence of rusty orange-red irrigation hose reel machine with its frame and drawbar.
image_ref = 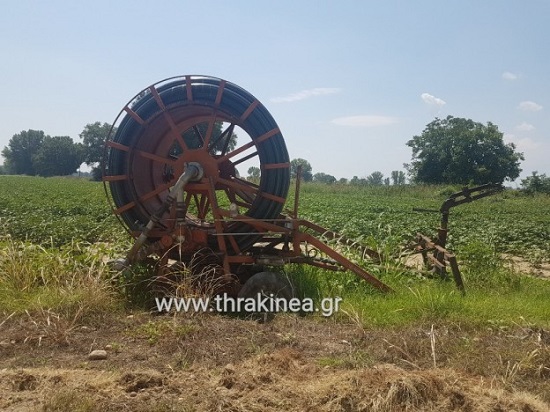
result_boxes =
[103,76,500,300]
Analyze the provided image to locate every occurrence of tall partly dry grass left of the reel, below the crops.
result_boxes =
[0,237,120,319]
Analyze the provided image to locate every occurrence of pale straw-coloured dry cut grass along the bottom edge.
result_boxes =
[2,358,549,412]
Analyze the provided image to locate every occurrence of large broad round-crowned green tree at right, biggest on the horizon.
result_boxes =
[406,116,524,184]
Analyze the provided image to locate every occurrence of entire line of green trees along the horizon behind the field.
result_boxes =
[0,116,550,193]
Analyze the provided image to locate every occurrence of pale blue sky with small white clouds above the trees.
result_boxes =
[0,0,550,183]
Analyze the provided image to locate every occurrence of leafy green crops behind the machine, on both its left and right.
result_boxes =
[0,176,550,259]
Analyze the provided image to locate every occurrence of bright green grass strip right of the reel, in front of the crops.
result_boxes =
[288,237,550,328]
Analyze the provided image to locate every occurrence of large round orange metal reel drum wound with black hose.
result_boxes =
[103,76,290,255]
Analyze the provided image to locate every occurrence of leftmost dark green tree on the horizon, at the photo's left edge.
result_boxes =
[2,130,45,176]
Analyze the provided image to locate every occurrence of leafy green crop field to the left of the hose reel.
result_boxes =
[0,176,121,246]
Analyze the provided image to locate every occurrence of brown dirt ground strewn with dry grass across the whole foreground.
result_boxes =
[0,312,550,412]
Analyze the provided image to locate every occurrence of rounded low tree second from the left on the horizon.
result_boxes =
[32,136,83,177]
